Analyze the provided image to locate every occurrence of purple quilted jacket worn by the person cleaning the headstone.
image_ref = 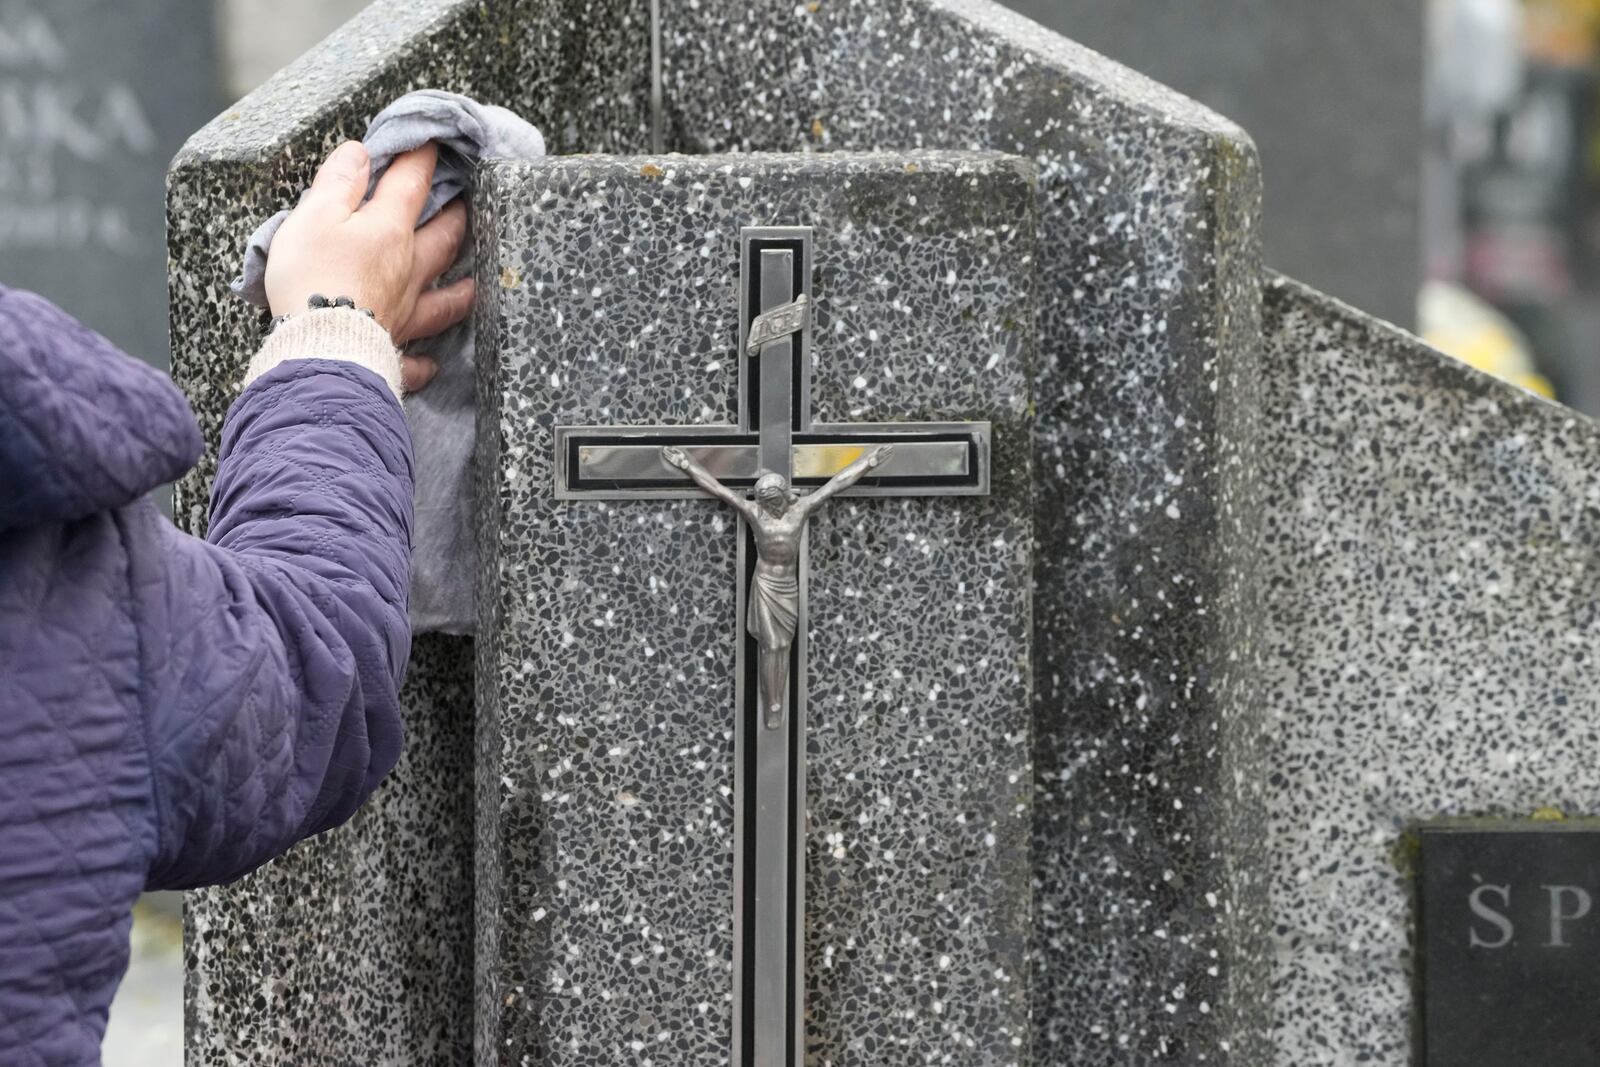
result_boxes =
[0,288,411,1067]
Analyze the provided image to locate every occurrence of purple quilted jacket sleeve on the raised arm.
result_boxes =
[136,360,413,888]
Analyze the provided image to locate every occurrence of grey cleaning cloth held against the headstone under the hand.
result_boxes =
[234,90,544,633]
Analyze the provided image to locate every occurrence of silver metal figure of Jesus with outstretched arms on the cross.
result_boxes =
[661,445,894,729]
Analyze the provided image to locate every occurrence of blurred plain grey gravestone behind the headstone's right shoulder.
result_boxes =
[1003,0,1424,325]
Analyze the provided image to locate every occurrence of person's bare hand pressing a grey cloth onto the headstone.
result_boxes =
[266,141,474,392]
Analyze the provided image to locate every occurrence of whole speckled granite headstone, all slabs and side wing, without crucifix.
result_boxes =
[170,0,1600,1067]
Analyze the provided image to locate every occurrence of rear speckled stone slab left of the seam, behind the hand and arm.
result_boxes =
[168,0,650,1067]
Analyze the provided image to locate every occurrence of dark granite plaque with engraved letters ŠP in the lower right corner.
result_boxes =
[1418,822,1600,1067]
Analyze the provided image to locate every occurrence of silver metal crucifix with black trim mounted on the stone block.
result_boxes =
[555,226,990,1067]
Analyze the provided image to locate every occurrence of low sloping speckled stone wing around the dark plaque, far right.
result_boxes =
[1235,278,1600,1067]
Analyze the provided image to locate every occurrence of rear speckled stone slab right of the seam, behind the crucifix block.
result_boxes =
[664,0,1266,1067]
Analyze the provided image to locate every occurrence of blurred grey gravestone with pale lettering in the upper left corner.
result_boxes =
[0,0,221,368]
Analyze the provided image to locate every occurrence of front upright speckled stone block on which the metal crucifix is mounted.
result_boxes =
[477,154,1037,1067]
